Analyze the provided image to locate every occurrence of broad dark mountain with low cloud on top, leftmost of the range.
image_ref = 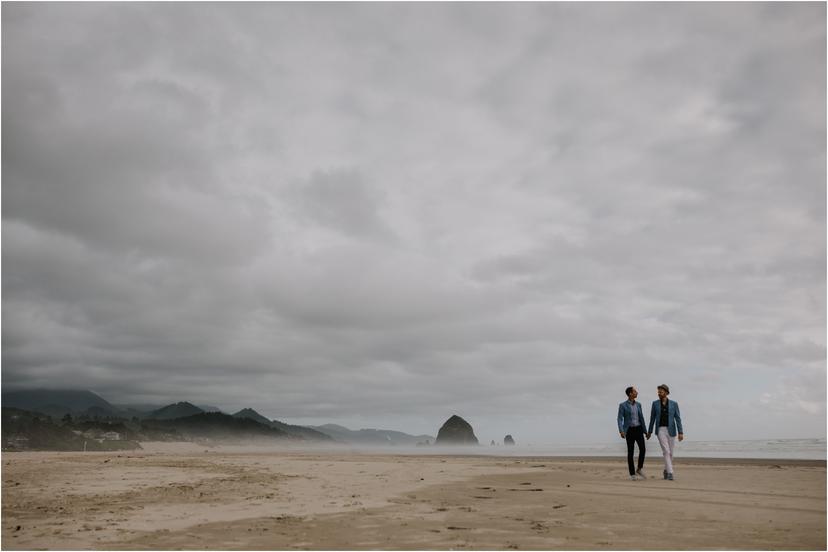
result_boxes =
[2,389,118,417]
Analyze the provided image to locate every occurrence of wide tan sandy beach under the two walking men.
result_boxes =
[2,444,826,550]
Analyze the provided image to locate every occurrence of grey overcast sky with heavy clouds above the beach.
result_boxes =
[2,3,826,444]
